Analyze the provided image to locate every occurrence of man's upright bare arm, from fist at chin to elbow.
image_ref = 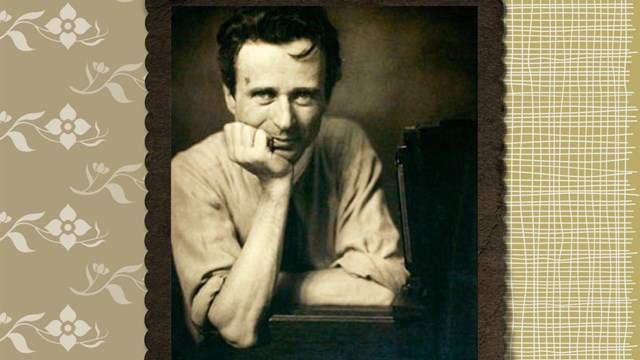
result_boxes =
[209,123,293,347]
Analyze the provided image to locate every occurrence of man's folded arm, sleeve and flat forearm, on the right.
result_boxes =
[285,121,408,305]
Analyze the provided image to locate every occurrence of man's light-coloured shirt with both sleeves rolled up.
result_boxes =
[171,117,409,338]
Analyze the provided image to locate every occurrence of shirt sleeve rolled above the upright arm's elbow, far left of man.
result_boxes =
[171,155,241,341]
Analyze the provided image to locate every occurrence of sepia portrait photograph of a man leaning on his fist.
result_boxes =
[171,6,478,359]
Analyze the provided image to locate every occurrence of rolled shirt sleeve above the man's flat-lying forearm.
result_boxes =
[332,121,409,293]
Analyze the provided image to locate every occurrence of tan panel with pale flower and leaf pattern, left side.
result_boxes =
[0,0,147,360]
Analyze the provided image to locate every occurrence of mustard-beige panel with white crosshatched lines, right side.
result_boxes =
[505,0,637,359]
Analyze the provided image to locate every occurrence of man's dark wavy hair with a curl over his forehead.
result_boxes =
[217,6,341,100]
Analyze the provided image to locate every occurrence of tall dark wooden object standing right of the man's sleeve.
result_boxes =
[397,119,477,359]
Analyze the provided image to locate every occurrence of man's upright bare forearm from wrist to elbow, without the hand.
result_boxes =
[209,179,291,347]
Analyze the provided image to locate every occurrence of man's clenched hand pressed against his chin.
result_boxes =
[224,122,293,185]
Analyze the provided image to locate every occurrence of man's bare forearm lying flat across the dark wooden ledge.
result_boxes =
[277,268,395,305]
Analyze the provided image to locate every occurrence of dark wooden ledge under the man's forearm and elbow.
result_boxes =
[174,300,476,360]
